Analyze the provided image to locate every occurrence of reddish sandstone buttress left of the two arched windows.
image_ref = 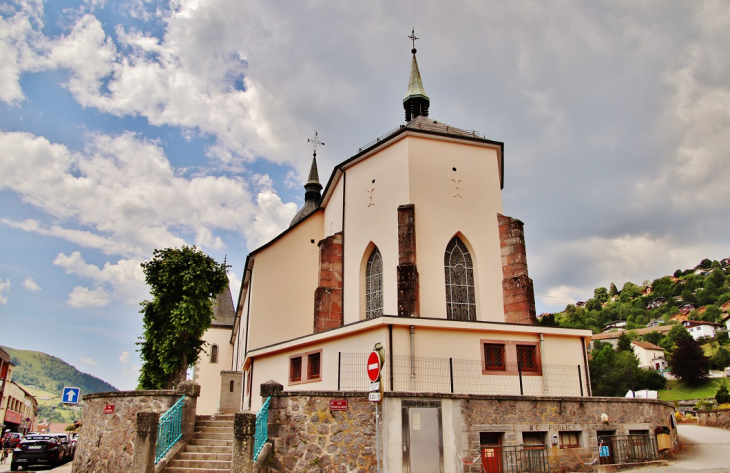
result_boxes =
[314,233,342,333]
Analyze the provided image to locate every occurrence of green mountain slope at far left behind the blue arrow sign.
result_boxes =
[2,347,117,395]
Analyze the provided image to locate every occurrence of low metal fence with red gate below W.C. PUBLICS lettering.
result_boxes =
[479,445,550,473]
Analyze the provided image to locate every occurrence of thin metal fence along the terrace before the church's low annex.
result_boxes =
[338,353,588,397]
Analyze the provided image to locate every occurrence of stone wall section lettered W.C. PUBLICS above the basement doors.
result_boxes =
[461,396,678,473]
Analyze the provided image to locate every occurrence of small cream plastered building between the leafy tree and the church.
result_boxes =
[193,328,233,415]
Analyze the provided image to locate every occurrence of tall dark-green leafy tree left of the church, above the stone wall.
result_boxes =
[138,246,228,389]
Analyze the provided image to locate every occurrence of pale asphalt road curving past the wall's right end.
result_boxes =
[626,424,730,473]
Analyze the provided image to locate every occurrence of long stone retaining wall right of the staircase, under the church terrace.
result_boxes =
[262,383,678,473]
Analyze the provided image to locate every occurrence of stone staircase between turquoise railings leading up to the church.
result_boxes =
[164,414,233,473]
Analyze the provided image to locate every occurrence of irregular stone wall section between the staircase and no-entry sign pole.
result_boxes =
[269,392,376,473]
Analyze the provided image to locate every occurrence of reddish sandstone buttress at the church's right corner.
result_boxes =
[497,214,537,325]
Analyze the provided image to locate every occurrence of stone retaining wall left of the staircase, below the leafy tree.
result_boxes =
[73,383,200,473]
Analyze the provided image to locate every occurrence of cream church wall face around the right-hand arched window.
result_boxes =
[407,136,504,322]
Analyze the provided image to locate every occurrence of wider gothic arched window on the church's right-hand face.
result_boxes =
[444,237,477,320]
